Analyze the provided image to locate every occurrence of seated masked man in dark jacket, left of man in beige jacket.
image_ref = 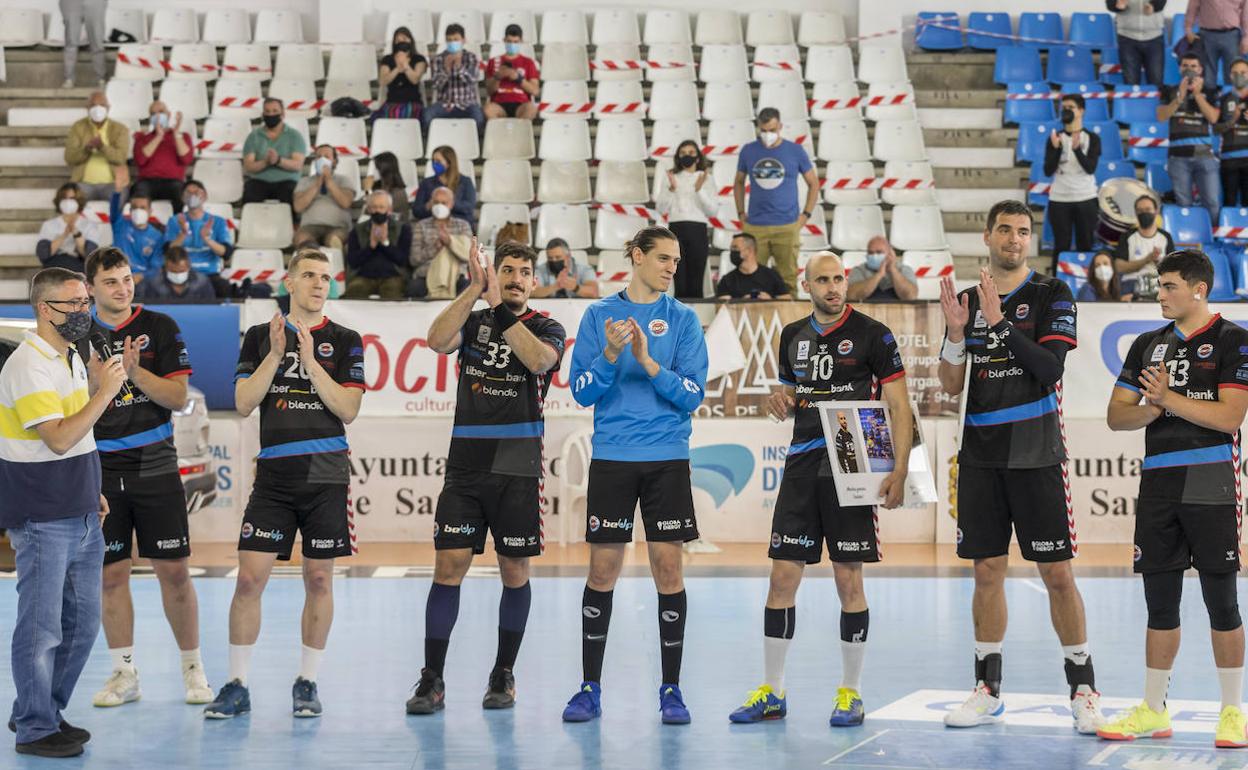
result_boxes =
[342,190,412,300]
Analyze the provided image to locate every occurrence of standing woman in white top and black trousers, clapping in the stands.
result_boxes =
[655,139,719,300]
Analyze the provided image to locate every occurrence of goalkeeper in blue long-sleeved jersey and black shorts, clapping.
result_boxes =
[563,227,706,724]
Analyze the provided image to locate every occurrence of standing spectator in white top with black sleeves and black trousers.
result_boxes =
[1045,94,1101,257]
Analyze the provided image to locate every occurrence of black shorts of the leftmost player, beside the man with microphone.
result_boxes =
[101,473,191,564]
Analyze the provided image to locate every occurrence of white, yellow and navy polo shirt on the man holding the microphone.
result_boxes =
[0,332,100,528]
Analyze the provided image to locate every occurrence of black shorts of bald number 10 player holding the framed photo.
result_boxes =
[768,474,880,564]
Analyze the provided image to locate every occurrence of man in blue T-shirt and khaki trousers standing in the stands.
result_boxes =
[733,107,819,295]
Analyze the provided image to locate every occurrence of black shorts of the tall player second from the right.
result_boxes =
[957,463,1078,562]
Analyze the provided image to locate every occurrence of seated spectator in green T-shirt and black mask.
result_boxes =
[239,99,308,207]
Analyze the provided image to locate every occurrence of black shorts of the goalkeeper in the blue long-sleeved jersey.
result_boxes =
[585,459,698,543]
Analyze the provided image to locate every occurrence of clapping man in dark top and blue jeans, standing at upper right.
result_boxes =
[1157,51,1222,222]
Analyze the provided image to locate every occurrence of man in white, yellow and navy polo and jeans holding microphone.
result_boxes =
[0,267,126,756]
